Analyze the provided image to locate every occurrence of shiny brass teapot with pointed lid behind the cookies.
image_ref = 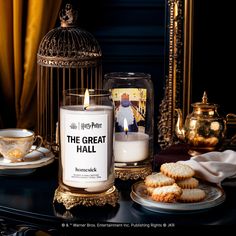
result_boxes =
[175,92,226,156]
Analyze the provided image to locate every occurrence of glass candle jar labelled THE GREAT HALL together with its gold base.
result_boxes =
[55,89,119,208]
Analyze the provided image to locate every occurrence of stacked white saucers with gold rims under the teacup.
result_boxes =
[0,146,55,175]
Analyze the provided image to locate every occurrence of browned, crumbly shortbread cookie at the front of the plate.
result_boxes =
[151,183,182,202]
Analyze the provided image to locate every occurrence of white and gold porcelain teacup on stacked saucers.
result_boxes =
[0,128,43,162]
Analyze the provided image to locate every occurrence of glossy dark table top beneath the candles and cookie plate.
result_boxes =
[0,144,236,235]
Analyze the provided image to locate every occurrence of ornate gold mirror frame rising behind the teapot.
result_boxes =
[158,0,194,149]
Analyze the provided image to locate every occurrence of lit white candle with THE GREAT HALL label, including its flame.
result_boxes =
[60,90,114,192]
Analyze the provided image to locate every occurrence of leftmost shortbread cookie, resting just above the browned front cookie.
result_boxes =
[144,172,175,187]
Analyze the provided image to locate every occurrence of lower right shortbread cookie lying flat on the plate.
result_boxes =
[178,188,206,202]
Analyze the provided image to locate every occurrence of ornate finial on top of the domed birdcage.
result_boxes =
[59,3,78,27]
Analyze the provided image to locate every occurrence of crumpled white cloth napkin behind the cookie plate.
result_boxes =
[178,150,236,183]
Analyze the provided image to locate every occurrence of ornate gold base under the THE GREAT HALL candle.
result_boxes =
[53,186,119,210]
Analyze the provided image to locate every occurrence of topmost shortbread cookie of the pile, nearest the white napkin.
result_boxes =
[160,162,195,180]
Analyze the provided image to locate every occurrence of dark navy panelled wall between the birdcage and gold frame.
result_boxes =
[63,0,166,148]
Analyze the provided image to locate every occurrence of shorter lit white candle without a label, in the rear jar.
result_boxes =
[113,119,149,162]
